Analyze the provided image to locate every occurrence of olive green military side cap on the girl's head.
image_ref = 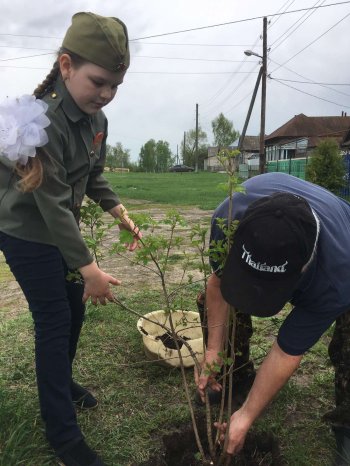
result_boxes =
[62,12,130,71]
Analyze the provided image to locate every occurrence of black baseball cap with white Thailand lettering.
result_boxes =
[221,193,319,317]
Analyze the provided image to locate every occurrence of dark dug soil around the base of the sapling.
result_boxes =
[134,416,286,466]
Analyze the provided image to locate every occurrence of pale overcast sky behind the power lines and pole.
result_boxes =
[0,0,350,161]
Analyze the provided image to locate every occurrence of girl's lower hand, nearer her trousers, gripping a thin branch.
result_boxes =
[79,262,121,305]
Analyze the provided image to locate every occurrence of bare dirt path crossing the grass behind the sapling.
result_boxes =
[0,206,212,320]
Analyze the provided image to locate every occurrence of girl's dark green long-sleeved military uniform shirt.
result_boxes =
[0,78,120,269]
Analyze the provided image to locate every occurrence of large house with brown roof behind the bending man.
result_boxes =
[265,112,350,162]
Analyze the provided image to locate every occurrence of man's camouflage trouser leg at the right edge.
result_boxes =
[323,311,350,428]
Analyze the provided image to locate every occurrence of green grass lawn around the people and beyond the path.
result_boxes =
[0,173,340,466]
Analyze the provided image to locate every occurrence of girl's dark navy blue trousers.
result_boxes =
[0,232,85,448]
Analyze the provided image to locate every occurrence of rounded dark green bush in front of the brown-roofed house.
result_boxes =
[305,139,346,193]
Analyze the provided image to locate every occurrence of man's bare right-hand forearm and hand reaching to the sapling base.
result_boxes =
[217,342,303,454]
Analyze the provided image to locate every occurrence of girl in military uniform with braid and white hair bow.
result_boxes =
[0,12,141,466]
